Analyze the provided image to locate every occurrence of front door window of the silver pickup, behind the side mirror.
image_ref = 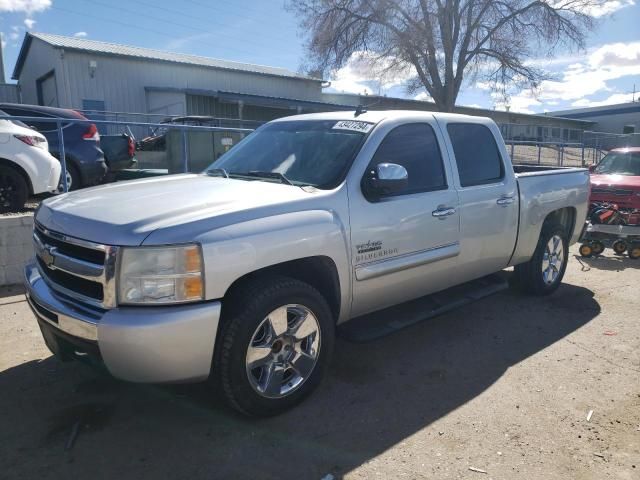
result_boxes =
[370,123,447,195]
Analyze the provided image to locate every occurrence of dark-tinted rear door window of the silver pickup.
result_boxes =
[447,123,504,187]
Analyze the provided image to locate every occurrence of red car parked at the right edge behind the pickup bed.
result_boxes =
[589,147,640,209]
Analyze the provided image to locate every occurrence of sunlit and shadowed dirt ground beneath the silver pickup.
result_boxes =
[0,248,640,480]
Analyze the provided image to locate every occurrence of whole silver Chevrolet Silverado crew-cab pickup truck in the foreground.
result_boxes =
[25,111,589,415]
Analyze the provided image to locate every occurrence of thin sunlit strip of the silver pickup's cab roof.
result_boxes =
[273,108,492,123]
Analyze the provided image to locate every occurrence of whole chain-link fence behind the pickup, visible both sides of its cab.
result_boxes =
[5,111,640,197]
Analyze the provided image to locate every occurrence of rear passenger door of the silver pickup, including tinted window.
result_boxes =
[442,117,519,280]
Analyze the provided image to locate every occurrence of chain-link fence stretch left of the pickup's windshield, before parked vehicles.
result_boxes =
[2,112,255,192]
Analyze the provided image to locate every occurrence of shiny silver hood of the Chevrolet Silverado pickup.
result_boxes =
[36,174,313,246]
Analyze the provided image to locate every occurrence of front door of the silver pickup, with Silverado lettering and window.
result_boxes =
[349,120,460,316]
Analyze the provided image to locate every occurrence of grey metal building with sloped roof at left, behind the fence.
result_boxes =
[13,33,344,121]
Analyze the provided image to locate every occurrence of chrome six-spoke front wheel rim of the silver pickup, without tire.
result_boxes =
[246,305,321,398]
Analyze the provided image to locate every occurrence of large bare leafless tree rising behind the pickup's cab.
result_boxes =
[289,0,606,112]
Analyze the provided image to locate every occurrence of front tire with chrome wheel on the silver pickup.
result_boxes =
[213,276,334,417]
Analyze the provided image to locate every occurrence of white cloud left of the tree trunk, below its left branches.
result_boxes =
[330,52,415,95]
